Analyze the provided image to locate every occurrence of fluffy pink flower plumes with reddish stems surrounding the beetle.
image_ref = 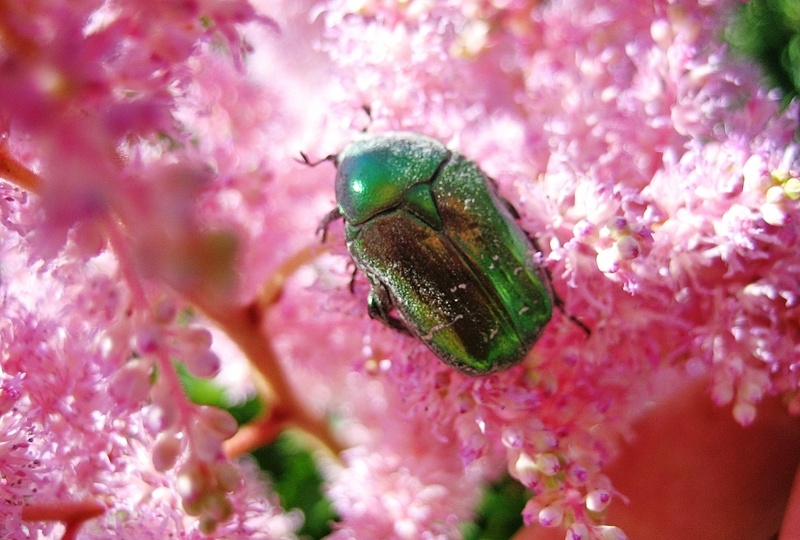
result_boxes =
[0,0,800,539]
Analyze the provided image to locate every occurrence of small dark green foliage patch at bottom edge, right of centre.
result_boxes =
[461,475,530,540]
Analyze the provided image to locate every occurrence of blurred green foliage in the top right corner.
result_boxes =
[725,0,800,106]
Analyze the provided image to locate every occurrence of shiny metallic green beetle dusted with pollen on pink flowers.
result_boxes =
[318,132,553,375]
